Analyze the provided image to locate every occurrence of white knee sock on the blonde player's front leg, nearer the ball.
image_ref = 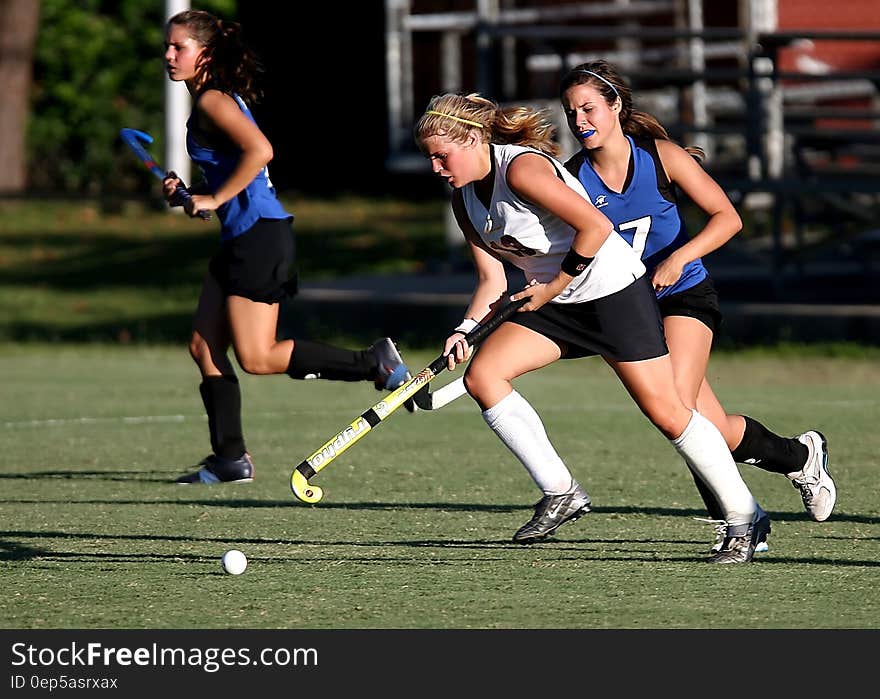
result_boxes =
[483,391,572,495]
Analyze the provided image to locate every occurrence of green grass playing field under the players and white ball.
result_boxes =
[0,344,880,629]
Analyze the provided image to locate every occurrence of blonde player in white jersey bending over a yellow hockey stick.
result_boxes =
[415,94,770,563]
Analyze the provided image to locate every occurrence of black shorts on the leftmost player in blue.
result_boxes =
[208,218,296,303]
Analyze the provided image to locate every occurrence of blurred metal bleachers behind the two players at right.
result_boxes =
[386,0,880,320]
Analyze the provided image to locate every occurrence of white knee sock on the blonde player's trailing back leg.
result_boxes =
[670,410,757,525]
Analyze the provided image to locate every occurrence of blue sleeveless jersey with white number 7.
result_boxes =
[565,136,707,297]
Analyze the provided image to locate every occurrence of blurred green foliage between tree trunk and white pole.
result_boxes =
[27,0,237,195]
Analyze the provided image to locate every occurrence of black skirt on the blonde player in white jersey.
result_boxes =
[510,275,669,362]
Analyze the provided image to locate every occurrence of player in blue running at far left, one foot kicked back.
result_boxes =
[164,10,409,484]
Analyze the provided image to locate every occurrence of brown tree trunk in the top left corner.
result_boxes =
[0,0,40,193]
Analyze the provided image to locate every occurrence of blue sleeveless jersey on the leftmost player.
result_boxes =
[186,95,293,240]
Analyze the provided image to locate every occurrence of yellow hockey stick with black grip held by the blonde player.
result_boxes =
[290,297,529,505]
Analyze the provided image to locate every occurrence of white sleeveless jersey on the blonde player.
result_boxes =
[461,144,645,303]
